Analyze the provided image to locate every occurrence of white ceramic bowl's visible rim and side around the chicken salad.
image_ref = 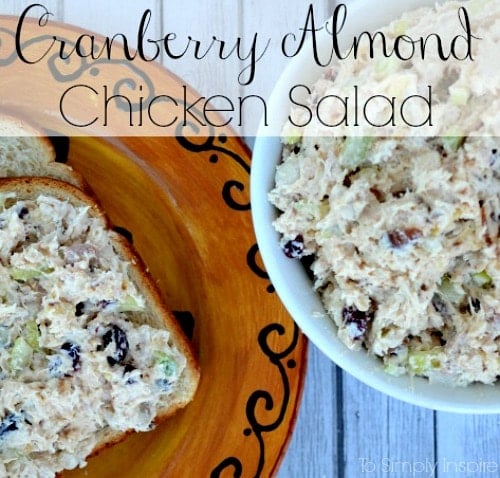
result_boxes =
[251,0,500,413]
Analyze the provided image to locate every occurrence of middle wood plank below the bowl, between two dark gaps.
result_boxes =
[339,374,435,477]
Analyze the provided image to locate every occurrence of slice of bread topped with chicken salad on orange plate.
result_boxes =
[0,178,199,477]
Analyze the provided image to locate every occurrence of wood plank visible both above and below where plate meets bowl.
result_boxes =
[262,0,343,478]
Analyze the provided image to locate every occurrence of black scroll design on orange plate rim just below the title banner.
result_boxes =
[176,133,250,211]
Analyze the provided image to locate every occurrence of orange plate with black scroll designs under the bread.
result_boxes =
[0,19,307,478]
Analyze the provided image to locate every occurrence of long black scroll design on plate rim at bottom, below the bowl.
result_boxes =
[210,323,299,478]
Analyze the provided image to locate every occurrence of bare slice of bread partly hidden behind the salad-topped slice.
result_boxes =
[0,115,86,189]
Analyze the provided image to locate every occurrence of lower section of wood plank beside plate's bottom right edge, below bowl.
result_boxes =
[278,344,341,478]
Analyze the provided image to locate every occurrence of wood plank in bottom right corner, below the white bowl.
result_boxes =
[436,412,500,478]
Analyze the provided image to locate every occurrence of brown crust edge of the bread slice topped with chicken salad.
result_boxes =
[0,177,200,472]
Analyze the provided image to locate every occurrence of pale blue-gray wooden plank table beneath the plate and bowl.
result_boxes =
[0,0,500,478]
